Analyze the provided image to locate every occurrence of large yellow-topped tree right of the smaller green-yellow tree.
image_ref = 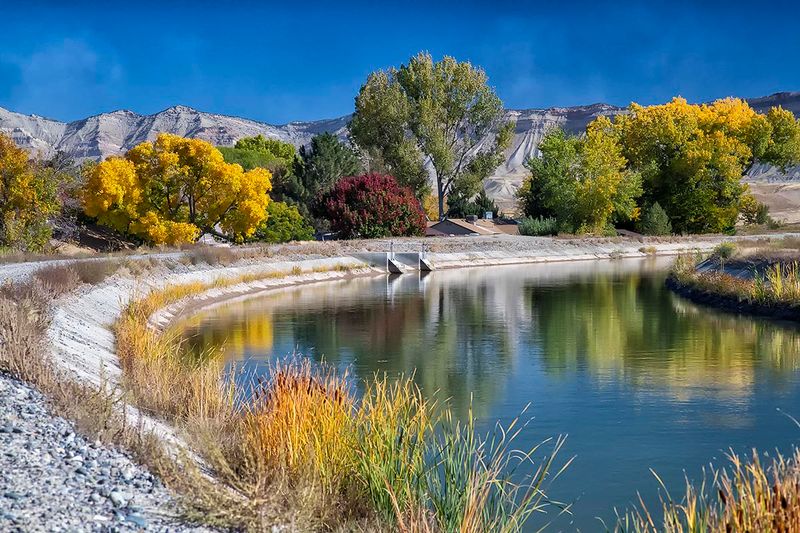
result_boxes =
[613,98,800,233]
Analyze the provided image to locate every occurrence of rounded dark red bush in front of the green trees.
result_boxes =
[319,174,425,239]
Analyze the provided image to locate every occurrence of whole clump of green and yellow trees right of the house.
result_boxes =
[519,98,800,233]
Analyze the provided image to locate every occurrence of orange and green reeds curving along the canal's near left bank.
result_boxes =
[116,271,563,532]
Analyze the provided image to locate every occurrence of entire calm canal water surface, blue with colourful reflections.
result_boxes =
[178,258,800,531]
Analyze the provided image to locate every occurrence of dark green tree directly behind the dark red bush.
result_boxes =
[299,133,363,198]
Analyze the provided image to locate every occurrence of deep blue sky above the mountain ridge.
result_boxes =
[0,0,800,123]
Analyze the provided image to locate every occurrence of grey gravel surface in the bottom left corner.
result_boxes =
[0,375,208,532]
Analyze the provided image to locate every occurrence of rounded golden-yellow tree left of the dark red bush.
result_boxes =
[82,133,272,245]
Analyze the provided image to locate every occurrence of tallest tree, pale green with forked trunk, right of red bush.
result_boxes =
[350,53,513,218]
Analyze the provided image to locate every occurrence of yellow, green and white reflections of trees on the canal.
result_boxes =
[180,260,800,416]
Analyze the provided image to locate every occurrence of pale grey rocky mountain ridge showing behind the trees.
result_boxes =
[0,92,800,200]
